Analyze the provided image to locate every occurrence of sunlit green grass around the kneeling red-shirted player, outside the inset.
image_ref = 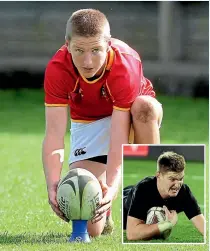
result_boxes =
[0,90,208,251]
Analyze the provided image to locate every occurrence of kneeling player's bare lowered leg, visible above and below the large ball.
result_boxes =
[70,160,106,237]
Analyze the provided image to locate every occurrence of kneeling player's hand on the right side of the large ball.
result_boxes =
[91,181,115,223]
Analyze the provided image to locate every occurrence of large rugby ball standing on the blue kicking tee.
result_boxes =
[57,168,102,220]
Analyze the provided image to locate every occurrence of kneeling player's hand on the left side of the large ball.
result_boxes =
[47,182,69,222]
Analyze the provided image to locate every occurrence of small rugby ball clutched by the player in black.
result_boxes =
[146,207,171,239]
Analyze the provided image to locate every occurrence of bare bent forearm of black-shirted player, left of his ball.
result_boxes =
[126,215,160,241]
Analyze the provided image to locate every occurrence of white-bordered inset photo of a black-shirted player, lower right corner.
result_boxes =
[122,144,207,244]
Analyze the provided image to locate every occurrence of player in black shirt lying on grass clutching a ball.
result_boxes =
[123,152,205,240]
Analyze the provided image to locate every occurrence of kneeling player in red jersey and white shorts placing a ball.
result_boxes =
[43,9,162,236]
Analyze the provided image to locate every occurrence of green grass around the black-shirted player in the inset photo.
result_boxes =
[123,158,204,243]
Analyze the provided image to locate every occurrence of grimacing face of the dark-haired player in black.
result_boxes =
[157,171,184,198]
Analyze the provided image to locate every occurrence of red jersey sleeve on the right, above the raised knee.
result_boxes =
[107,55,155,110]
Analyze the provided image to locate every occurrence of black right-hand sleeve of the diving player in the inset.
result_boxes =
[183,184,201,220]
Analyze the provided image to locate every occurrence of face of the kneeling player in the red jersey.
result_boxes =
[68,36,109,78]
